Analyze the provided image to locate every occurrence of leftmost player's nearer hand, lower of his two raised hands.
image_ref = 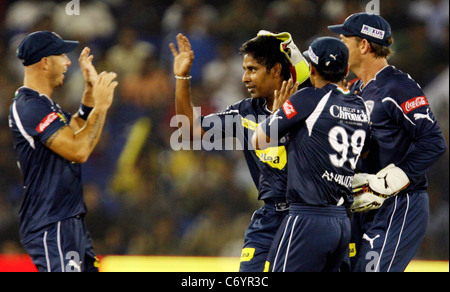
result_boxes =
[93,72,119,109]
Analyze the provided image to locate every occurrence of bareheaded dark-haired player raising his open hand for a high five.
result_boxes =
[170,31,309,272]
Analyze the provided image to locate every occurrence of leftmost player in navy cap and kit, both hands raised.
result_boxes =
[9,31,118,272]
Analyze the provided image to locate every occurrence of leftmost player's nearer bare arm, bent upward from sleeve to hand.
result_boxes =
[46,72,118,163]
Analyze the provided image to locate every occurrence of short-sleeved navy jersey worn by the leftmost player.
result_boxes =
[9,87,86,243]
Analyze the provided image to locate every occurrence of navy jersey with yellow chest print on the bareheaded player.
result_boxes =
[202,98,287,202]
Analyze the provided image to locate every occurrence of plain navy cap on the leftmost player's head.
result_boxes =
[16,31,79,66]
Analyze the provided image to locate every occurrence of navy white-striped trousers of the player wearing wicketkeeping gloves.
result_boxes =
[350,191,429,272]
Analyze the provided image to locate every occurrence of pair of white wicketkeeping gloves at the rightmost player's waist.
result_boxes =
[351,164,409,212]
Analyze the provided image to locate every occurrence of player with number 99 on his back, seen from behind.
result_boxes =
[252,37,369,272]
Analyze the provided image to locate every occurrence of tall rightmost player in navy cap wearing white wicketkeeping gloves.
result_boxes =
[328,13,447,272]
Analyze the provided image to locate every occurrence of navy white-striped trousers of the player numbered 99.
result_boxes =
[268,204,350,272]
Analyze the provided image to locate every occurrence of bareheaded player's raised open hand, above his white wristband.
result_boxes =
[169,33,194,77]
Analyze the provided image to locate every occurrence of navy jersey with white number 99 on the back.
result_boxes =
[262,84,369,206]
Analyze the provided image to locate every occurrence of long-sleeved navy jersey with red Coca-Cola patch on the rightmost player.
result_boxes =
[352,66,446,193]
